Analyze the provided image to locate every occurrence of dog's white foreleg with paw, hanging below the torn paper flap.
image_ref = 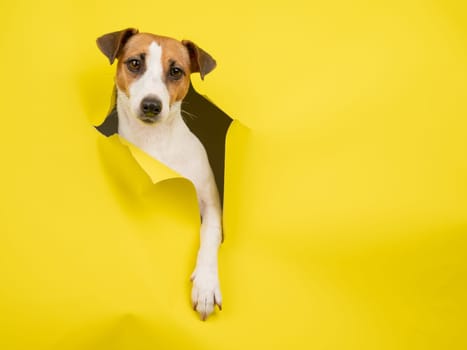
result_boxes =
[191,202,222,321]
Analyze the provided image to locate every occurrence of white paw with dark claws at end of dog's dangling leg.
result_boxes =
[191,267,222,321]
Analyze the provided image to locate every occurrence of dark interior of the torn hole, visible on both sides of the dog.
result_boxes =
[96,84,232,203]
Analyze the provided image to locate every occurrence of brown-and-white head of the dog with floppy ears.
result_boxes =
[97,28,216,124]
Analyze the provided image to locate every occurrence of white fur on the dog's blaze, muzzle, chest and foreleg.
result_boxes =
[117,42,222,320]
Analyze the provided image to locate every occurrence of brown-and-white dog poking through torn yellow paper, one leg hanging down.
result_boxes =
[97,28,222,321]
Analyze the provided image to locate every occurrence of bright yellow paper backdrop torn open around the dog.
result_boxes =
[0,0,467,350]
